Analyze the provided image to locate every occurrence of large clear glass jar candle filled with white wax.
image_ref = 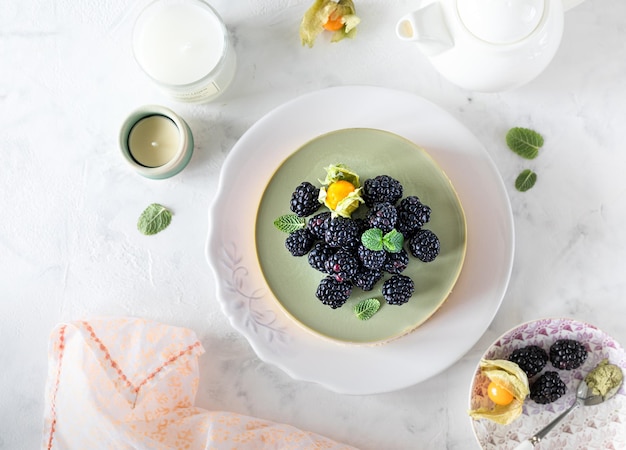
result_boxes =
[133,0,236,103]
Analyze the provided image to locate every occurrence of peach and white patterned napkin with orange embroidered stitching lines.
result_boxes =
[42,318,354,450]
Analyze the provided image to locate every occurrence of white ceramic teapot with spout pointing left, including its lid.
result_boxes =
[396,0,584,92]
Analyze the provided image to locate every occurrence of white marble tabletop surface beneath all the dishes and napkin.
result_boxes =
[0,0,626,450]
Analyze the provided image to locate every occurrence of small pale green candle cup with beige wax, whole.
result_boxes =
[119,105,193,179]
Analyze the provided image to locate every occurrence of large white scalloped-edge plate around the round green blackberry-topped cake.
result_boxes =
[206,86,514,394]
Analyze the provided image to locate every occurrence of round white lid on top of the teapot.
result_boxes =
[456,0,545,44]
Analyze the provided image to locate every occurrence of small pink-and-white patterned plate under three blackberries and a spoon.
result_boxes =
[469,319,626,450]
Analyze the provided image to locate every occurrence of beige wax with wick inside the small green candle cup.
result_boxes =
[128,115,181,167]
